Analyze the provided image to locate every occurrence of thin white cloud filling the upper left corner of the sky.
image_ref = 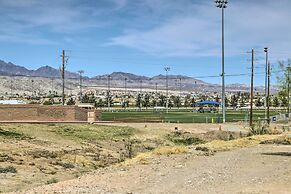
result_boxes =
[0,0,127,44]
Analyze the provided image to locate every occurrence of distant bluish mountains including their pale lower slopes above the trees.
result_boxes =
[0,60,275,92]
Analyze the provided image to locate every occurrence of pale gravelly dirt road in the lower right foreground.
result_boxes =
[21,145,291,194]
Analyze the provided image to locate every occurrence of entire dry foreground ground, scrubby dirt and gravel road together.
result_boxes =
[0,123,291,193]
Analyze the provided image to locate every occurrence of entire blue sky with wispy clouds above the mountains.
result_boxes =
[0,0,291,85]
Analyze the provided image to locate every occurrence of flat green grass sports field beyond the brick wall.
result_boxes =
[102,110,276,123]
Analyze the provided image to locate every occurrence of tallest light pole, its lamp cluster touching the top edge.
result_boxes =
[214,0,228,123]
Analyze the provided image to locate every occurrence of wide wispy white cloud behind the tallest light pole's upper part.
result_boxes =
[110,0,291,57]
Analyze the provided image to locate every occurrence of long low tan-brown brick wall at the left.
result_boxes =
[0,105,94,121]
